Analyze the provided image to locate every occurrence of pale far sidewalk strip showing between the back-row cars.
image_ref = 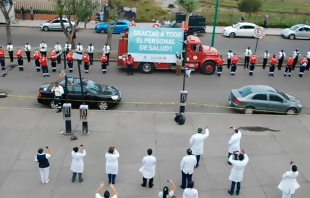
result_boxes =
[11,20,283,36]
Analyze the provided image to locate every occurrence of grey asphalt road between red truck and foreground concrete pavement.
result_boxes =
[0,62,310,114]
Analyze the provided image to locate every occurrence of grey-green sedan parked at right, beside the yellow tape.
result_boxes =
[228,85,302,115]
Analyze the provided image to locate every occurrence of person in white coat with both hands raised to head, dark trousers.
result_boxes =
[228,149,249,195]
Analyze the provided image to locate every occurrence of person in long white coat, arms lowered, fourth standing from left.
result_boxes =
[139,149,156,188]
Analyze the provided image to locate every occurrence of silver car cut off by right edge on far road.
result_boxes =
[281,24,310,40]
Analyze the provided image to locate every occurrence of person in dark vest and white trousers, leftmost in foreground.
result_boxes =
[34,146,52,184]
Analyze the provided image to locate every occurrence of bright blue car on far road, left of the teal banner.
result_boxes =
[95,20,131,34]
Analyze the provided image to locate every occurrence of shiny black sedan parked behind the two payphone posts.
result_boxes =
[38,77,122,110]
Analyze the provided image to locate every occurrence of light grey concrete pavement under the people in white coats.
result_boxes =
[0,109,310,198]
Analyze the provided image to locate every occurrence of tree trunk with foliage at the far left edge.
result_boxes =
[0,0,14,43]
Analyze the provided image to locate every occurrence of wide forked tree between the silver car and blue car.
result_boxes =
[54,0,98,49]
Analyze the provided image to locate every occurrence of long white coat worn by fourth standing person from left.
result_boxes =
[139,155,156,179]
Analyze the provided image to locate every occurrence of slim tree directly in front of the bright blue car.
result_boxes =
[106,0,124,46]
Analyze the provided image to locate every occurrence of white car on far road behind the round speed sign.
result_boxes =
[223,22,263,38]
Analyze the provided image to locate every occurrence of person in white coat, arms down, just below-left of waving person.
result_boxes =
[180,149,197,190]
